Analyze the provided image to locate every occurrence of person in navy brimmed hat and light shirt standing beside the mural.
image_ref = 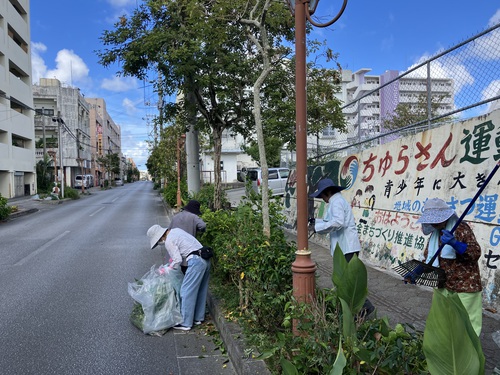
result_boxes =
[309,178,375,316]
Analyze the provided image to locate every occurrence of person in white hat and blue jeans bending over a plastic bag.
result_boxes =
[147,225,210,331]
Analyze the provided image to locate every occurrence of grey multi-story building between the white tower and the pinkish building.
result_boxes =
[33,78,92,191]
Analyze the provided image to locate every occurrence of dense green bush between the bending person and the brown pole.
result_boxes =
[201,197,295,333]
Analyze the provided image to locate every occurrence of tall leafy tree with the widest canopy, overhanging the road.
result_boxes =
[98,0,252,208]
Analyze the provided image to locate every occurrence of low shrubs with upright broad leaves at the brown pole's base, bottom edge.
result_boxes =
[250,247,428,375]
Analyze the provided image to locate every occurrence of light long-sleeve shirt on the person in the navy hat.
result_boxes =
[314,193,361,256]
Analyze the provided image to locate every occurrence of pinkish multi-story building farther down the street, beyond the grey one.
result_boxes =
[85,98,125,184]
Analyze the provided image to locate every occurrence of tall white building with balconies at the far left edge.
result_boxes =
[0,0,36,198]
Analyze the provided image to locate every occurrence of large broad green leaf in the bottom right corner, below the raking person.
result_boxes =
[423,289,484,375]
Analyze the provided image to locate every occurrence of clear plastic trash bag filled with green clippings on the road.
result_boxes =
[128,266,184,334]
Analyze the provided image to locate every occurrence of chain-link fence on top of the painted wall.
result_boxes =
[308,24,500,163]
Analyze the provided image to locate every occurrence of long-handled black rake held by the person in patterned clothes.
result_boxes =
[394,161,500,288]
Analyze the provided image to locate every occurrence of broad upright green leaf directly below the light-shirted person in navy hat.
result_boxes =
[332,246,368,314]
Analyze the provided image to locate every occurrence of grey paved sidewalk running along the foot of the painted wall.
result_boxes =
[287,232,500,375]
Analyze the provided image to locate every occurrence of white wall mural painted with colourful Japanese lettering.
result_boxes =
[285,110,500,311]
